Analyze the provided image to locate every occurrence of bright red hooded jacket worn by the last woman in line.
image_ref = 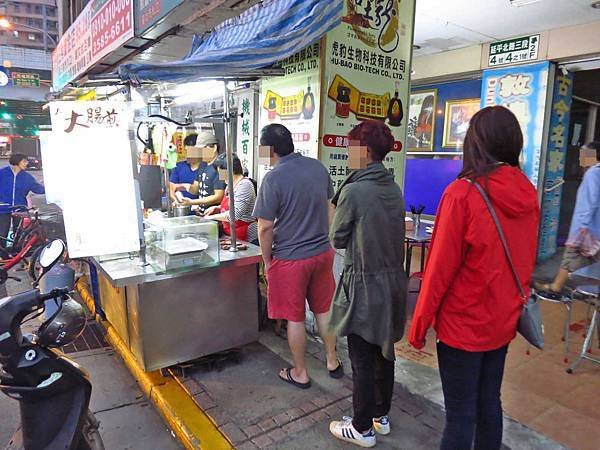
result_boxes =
[409,166,540,352]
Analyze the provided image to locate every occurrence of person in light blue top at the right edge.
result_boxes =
[534,141,600,292]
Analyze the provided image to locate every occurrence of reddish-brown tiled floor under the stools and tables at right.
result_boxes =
[396,253,600,450]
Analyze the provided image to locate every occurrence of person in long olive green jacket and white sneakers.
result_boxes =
[329,121,407,447]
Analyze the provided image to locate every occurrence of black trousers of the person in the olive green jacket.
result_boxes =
[348,334,394,433]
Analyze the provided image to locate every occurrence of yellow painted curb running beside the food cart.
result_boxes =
[76,277,234,450]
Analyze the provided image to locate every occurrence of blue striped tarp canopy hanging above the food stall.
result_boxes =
[119,0,343,83]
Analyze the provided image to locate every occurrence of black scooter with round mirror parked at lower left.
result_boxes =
[0,240,104,450]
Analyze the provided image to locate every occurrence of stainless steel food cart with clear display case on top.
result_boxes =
[91,78,273,371]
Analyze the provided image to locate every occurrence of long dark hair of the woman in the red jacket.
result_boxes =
[458,106,523,180]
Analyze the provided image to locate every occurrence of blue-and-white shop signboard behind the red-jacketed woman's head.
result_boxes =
[481,62,550,187]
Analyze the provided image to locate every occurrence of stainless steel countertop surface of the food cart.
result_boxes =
[92,244,261,287]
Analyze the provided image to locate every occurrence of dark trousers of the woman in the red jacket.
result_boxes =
[437,342,508,450]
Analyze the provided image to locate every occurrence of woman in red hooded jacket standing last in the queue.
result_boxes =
[409,106,540,450]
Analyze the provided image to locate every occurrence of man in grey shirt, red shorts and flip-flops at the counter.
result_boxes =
[254,124,344,389]
